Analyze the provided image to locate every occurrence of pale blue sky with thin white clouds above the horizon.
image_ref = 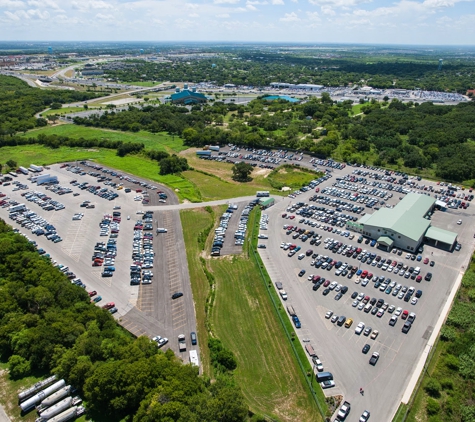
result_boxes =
[0,0,475,45]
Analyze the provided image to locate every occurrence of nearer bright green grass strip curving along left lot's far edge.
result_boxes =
[2,145,201,202]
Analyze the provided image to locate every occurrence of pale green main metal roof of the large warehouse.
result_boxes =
[358,193,435,241]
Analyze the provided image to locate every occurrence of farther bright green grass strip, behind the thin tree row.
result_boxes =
[23,125,187,153]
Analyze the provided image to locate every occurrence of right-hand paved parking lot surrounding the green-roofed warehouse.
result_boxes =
[259,166,475,420]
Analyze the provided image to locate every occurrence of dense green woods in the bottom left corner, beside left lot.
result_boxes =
[0,220,248,422]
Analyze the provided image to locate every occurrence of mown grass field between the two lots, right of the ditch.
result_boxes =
[208,209,320,421]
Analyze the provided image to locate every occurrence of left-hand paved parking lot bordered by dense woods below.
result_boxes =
[0,163,197,362]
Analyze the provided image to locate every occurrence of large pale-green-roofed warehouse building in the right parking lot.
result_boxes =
[348,193,457,252]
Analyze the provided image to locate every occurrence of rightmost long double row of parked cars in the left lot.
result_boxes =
[130,211,155,285]
